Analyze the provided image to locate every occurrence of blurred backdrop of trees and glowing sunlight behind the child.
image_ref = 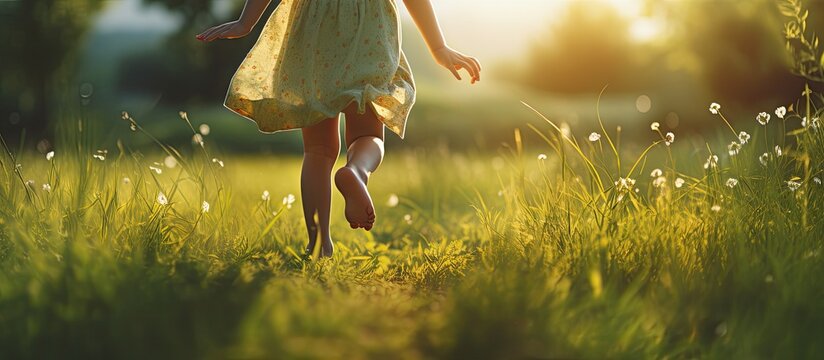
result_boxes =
[0,0,824,153]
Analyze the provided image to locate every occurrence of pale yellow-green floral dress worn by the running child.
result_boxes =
[224,0,415,138]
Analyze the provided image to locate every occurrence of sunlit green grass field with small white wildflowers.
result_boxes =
[0,96,824,359]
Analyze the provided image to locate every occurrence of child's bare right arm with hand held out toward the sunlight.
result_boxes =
[403,0,481,84]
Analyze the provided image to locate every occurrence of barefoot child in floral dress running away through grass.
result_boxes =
[197,0,481,257]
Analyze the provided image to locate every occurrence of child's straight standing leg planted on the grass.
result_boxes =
[300,118,340,256]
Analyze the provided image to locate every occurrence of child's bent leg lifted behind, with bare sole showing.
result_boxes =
[335,104,384,230]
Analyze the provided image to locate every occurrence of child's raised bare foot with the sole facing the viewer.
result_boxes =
[335,166,375,231]
